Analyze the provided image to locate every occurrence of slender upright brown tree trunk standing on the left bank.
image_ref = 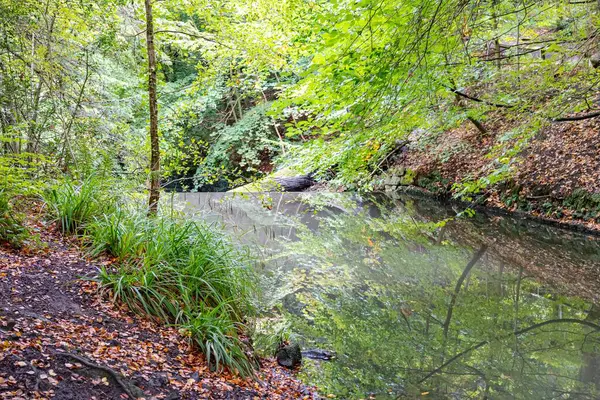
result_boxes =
[145,0,160,214]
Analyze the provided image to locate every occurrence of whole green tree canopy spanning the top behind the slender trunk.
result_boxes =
[0,0,598,198]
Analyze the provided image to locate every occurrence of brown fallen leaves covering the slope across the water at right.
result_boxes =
[395,111,600,230]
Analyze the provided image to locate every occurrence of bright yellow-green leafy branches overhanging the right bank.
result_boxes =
[264,0,598,195]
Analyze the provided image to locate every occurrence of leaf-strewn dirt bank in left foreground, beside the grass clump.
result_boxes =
[0,217,317,400]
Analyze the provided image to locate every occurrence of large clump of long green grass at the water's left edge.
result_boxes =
[86,208,255,376]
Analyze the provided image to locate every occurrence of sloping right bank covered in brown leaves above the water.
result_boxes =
[382,112,600,231]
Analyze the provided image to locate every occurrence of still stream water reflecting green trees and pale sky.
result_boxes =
[177,193,600,399]
